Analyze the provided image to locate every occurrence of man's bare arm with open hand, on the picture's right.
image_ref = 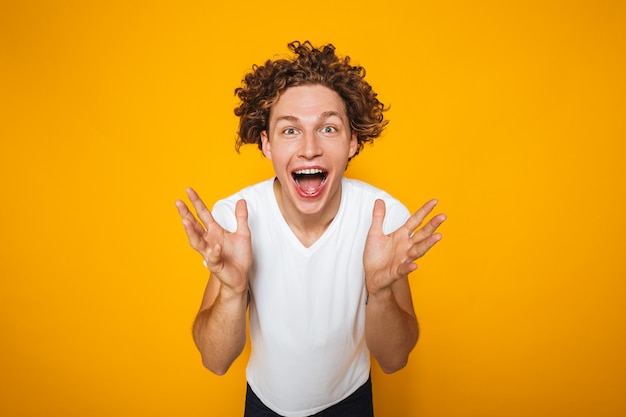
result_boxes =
[364,200,446,373]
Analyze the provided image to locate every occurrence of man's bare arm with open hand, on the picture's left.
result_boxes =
[176,189,252,375]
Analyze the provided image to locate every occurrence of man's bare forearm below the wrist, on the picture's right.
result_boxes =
[365,288,419,373]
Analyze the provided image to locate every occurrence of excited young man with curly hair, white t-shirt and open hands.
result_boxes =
[176,42,445,417]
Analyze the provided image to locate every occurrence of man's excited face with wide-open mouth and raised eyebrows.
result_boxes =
[261,85,357,221]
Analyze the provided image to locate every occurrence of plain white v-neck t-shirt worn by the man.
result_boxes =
[212,178,410,417]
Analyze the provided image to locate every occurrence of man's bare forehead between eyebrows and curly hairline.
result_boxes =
[270,85,347,121]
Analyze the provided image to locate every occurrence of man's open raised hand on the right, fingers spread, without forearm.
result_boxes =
[363,200,446,294]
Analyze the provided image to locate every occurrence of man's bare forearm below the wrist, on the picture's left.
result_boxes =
[193,292,248,375]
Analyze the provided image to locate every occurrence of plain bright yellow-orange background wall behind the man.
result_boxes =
[0,0,626,417]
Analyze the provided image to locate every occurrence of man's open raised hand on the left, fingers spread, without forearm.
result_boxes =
[176,188,252,294]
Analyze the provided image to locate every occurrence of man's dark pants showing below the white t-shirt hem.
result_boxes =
[244,377,374,417]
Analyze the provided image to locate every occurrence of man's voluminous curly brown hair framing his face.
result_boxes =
[235,41,389,156]
